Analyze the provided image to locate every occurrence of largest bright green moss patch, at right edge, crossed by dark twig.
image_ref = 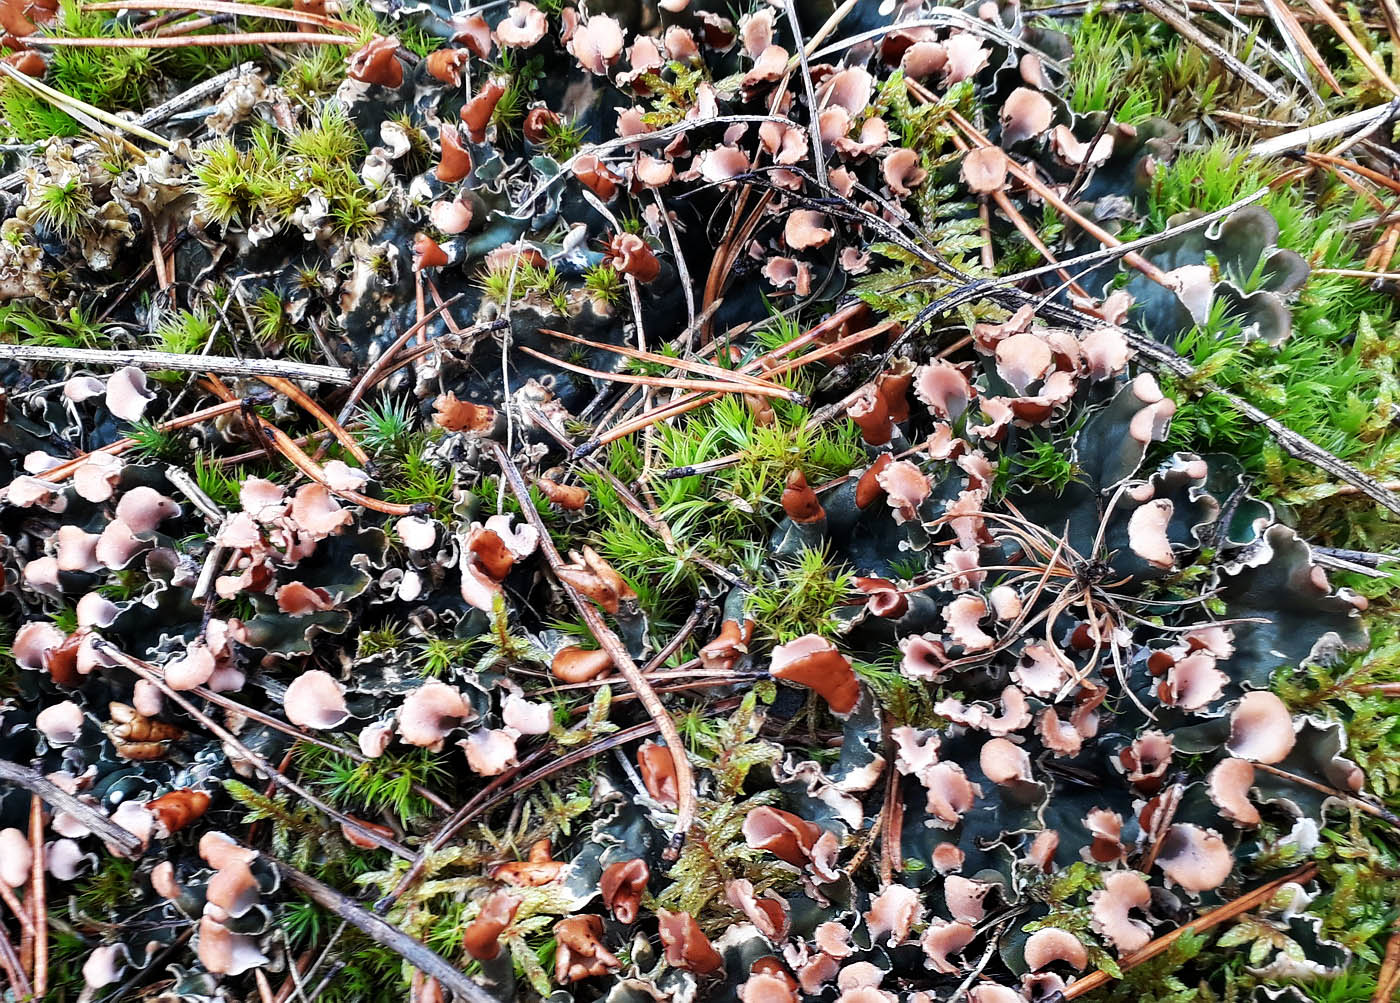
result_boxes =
[1148,143,1400,523]
